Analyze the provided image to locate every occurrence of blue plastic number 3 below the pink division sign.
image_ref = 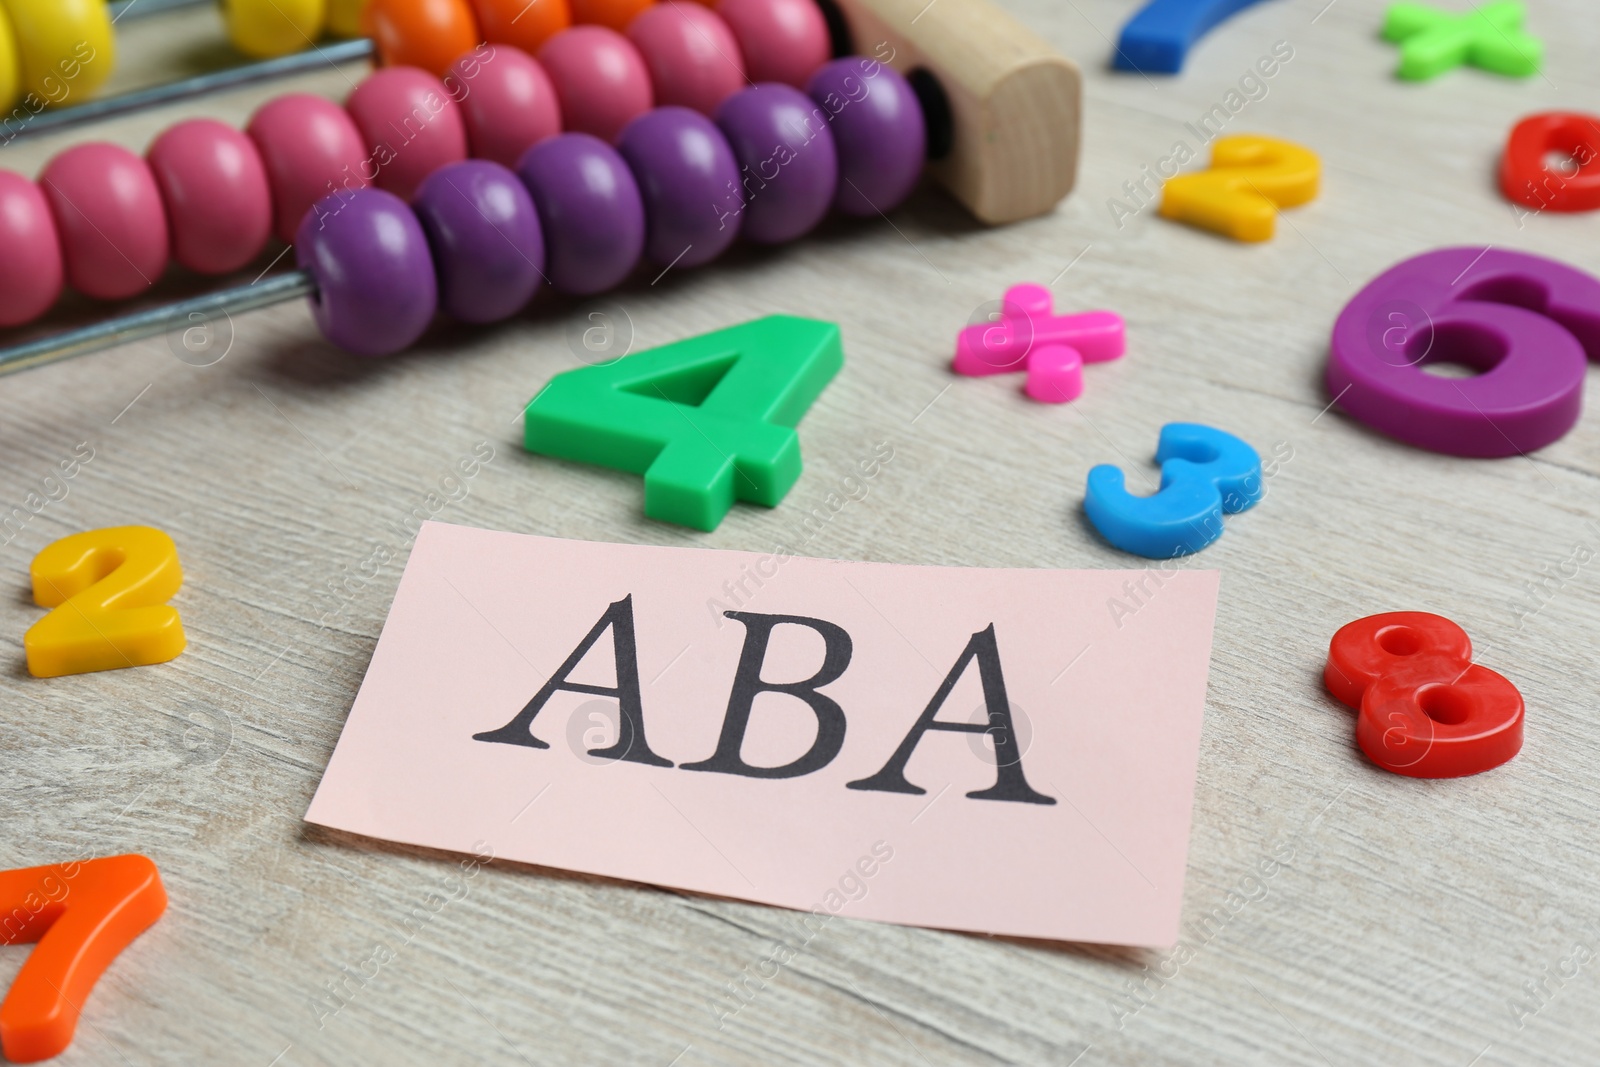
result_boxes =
[1083,422,1266,560]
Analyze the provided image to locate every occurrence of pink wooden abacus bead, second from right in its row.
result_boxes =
[627,0,746,115]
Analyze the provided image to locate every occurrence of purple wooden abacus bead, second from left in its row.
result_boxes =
[411,160,544,323]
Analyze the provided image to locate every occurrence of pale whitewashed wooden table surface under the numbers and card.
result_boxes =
[0,0,1600,1067]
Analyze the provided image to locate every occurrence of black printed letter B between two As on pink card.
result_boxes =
[683,611,853,777]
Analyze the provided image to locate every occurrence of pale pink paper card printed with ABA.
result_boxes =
[306,523,1218,945]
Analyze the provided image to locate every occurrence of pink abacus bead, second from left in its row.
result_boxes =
[38,142,168,301]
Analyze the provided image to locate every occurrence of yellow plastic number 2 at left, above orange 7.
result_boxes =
[22,526,187,678]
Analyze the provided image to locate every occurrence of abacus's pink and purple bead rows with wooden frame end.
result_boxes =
[0,0,1078,370]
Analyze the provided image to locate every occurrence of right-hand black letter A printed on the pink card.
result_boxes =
[846,622,1056,805]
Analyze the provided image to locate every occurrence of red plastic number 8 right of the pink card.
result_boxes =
[1322,611,1523,777]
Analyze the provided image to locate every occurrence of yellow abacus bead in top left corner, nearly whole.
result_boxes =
[5,0,117,104]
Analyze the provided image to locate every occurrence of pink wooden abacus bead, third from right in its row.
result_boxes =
[539,25,652,142]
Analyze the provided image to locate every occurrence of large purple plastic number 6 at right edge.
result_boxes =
[1328,248,1600,456]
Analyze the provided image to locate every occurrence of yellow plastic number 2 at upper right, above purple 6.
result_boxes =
[1162,134,1322,242]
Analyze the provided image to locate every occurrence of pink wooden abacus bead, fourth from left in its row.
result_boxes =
[245,93,376,245]
